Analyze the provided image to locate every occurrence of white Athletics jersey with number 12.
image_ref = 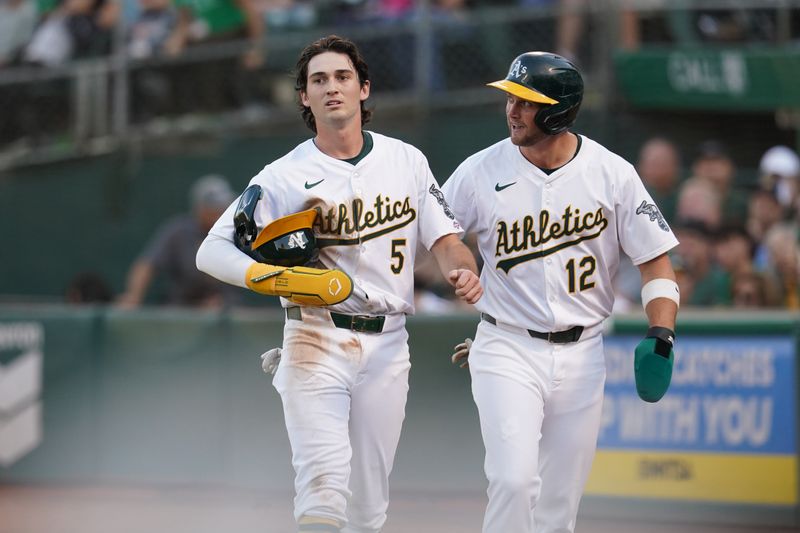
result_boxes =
[442,136,678,331]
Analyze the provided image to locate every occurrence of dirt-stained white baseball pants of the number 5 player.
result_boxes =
[273,308,411,533]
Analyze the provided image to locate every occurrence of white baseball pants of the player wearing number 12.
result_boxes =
[469,321,605,533]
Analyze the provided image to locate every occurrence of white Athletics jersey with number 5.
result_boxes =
[203,132,461,315]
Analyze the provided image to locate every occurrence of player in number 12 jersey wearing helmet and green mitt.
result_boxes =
[442,52,679,533]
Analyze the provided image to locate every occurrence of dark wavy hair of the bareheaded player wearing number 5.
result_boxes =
[294,35,372,133]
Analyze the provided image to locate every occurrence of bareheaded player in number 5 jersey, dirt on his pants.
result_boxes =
[197,36,482,533]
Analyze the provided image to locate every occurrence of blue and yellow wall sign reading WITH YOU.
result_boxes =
[588,336,797,504]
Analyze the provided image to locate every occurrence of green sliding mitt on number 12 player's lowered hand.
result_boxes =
[633,327,675,403]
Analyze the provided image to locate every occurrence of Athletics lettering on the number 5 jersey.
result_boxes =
[314,194,417,248]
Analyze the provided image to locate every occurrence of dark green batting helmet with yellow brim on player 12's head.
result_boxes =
[488,52,583,135]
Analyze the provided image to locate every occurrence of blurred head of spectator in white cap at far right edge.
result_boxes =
[758,146,800,218]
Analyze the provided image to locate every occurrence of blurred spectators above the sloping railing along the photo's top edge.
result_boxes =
[0,0,800,68]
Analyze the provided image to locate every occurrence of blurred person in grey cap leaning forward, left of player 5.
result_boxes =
[117,175,238,309]
